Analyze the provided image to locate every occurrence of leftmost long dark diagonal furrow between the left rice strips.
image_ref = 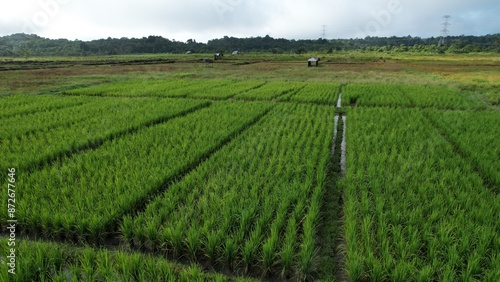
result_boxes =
[15,102,211,173]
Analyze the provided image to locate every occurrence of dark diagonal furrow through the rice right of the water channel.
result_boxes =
[422,111,500,194]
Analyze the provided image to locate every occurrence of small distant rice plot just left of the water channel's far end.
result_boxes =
[290,83,340,105]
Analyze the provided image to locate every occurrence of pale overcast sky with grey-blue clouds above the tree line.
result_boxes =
[0,0,500,42]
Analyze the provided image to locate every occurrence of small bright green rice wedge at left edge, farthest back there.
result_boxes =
[0,95,92,119]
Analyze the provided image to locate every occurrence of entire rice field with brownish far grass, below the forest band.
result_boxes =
[0,53,500,281]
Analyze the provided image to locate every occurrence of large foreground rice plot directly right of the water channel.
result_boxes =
[344,108,500,281]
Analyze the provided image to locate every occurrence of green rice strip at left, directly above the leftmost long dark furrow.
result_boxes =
[0,97,208,170]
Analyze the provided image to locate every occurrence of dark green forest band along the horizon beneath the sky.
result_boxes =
[0,33,500,57]
